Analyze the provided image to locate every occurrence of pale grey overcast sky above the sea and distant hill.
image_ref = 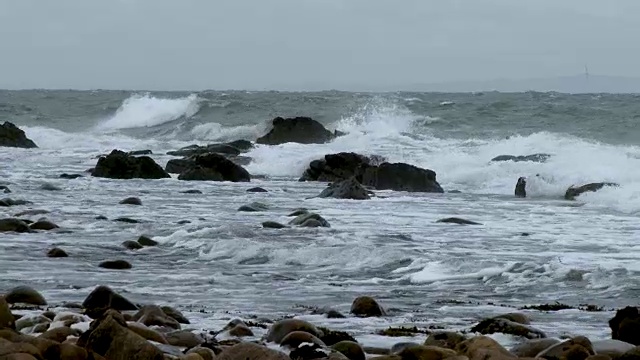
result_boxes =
[0,0,640,90]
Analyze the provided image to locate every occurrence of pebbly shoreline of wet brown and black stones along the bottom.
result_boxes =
[0,286,640,360]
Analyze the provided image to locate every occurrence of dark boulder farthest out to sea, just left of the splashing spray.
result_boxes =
[256,117,336,145]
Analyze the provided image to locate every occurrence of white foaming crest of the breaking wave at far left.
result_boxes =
[97,94,202,130]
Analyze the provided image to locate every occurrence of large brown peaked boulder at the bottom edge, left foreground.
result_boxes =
[77,310,165,360]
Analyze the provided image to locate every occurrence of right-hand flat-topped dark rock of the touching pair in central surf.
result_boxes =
[360,163,444,193]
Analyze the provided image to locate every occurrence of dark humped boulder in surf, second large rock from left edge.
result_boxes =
[91,150,170,179]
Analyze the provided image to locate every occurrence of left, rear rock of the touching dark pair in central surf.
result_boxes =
[299,152,385,182]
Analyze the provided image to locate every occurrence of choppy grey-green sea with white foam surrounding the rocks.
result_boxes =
[0,91,640,346]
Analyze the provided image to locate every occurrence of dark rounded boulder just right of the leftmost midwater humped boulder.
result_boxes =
[178,153,251,182]
